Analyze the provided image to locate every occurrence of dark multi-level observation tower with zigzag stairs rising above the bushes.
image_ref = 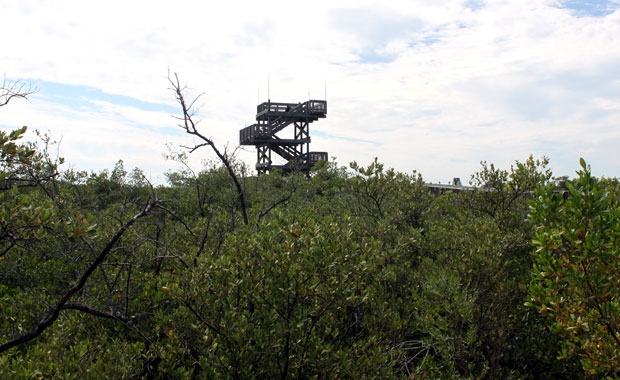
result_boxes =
[239,100,327,175]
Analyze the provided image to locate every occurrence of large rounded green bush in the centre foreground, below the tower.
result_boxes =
[165,211,394,378]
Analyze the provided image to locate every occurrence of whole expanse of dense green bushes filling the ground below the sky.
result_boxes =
[0,90,620,379]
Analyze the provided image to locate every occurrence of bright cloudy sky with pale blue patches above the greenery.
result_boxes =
[0,0,620,183]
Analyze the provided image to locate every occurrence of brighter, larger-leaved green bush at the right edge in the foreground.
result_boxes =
[530,159,620,376]
